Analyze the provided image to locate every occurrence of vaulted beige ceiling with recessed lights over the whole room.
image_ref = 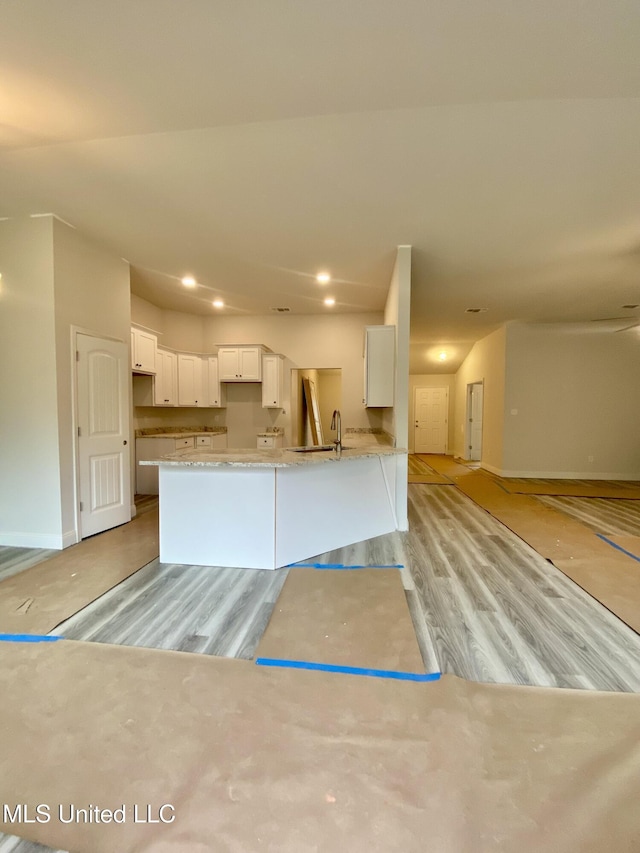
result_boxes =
[0,0,640,372]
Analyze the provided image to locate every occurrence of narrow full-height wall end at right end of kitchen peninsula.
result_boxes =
[382,246,411,530]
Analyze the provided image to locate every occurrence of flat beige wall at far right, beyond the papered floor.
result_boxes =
[503,323,640,479]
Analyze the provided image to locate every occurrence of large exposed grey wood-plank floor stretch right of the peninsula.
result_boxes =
[406,486,640,692]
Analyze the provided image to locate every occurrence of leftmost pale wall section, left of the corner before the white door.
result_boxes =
[0,217,62,548]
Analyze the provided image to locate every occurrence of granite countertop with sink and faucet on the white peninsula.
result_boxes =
[139,446,407,468]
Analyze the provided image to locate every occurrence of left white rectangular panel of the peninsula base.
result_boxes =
[160,465,275,569]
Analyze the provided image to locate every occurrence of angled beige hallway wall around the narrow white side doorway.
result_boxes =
[453,327,506,473]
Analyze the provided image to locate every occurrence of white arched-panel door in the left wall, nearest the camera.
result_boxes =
[76,335,131,539]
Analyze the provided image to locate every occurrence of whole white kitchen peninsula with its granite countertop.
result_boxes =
[140,446,407,569]
